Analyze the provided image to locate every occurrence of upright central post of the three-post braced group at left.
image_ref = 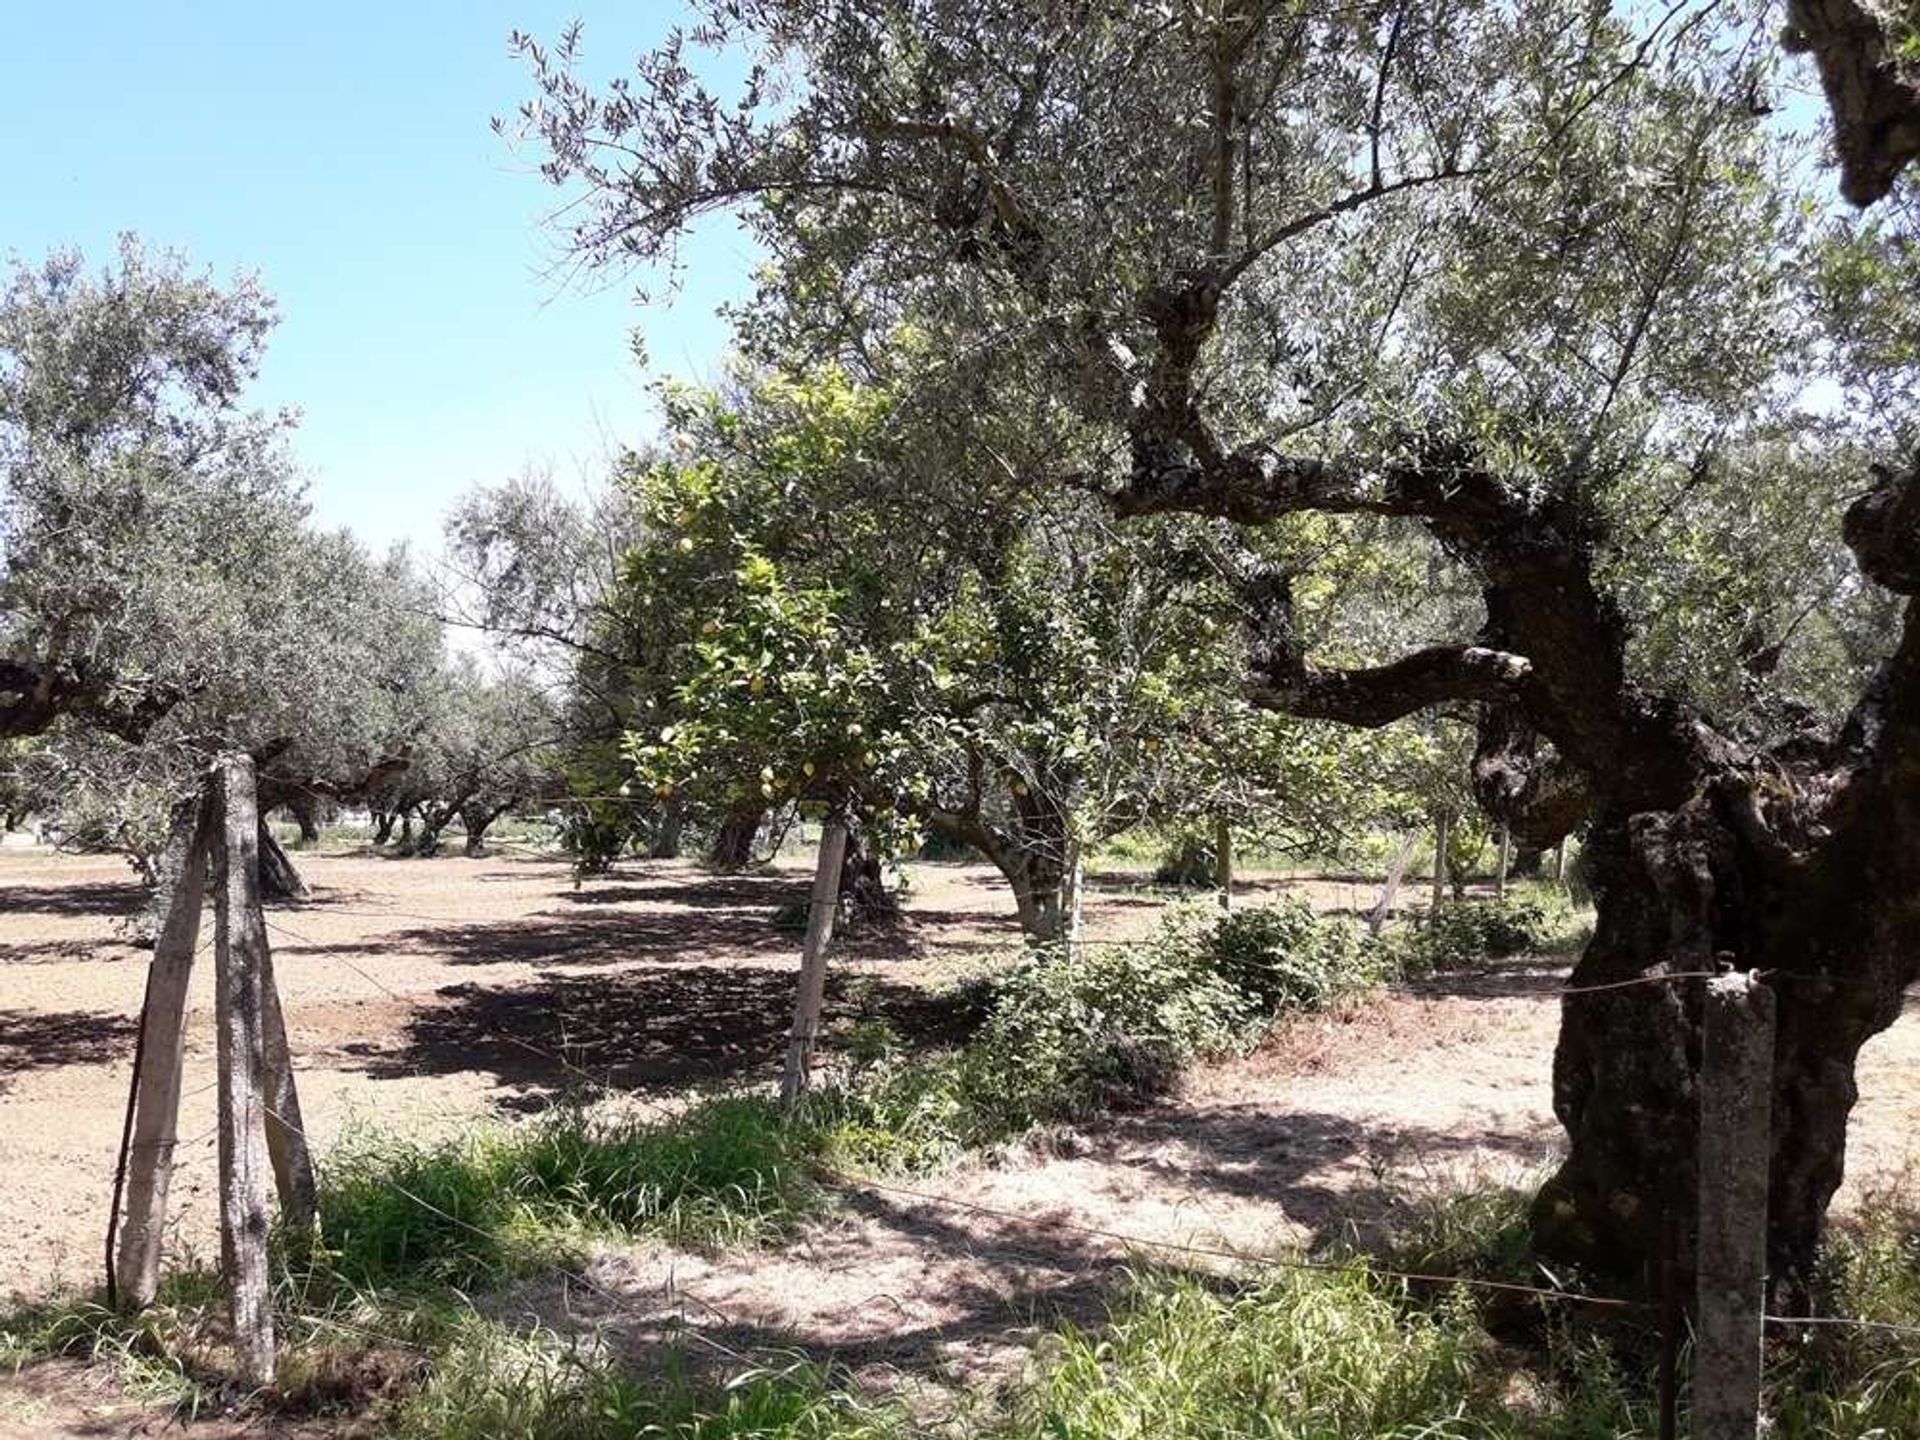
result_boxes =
[213,755,273,1386]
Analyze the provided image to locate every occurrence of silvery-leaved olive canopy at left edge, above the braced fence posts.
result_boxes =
[0,240,453,885]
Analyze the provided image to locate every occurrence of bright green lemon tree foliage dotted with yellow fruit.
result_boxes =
[620,369,1390,935]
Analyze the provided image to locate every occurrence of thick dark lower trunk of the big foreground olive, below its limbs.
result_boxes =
[1534,737,1920,1311]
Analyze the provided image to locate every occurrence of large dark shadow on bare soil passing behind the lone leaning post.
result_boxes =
[346,966,973,1108]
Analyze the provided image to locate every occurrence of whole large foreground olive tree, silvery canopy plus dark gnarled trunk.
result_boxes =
[506,0,1920,1304]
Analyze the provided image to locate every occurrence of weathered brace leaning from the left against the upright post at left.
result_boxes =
[111,799,211,1309]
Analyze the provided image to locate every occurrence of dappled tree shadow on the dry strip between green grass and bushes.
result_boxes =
[540,1106,1542,1384]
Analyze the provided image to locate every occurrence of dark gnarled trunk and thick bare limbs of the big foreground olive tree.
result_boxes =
[1121,414,1920,1306]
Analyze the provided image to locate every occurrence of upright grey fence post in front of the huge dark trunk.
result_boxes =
[1692,973,1774,1440]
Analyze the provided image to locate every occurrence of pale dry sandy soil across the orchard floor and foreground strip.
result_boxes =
[0,847,1920,1440]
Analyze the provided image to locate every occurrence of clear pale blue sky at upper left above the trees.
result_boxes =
[0,0,753,545]
